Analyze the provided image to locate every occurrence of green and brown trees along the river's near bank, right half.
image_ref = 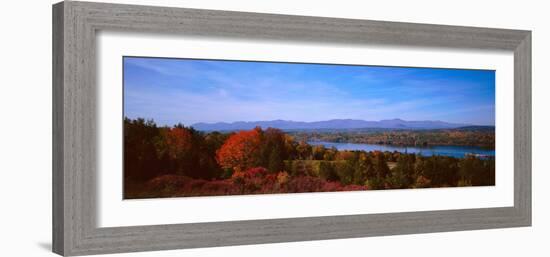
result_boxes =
[285,146,495,189]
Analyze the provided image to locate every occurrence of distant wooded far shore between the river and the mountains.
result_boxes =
[289,128,495,149]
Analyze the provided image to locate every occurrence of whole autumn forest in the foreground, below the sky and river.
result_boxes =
[124,118,495,199]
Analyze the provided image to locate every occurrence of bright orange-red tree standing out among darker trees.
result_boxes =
[216,128,262,171]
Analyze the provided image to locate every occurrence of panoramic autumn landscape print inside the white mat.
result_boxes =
[123,57,495,199]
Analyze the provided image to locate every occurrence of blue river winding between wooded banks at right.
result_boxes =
[308,141,495,158]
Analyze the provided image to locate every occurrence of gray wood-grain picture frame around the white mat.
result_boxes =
[53,1,531,255]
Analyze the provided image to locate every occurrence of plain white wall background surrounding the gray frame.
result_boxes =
[0,0,550,257]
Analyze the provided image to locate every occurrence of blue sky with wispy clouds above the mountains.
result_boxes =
[123,57,495,125]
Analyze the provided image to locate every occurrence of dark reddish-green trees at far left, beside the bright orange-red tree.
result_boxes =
[124,118,228,181]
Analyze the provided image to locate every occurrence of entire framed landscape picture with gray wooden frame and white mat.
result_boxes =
[53,1,531,256]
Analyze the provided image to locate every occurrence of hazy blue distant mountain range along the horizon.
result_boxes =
[192,119,484,131]
